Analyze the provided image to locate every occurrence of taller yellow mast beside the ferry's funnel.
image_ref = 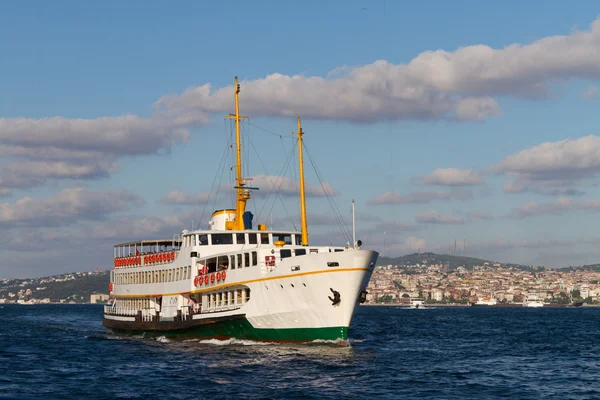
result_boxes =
[225,76,250,230]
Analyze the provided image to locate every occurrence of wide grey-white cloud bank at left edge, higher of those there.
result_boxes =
[0,115,189,190]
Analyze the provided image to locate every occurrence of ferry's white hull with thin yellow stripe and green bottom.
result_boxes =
[104,247,377,341]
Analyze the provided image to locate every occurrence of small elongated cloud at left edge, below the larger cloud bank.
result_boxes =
[0,188,144,228]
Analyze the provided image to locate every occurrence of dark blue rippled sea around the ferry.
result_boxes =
[0,305,600,400]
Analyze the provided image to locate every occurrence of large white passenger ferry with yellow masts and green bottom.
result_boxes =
[102,77,378,342]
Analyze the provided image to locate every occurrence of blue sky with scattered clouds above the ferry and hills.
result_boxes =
[0,0,600,278]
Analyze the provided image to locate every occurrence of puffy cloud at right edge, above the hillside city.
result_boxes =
[491,136,600,196]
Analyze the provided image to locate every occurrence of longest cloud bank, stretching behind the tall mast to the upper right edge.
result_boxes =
[157,20,600,122]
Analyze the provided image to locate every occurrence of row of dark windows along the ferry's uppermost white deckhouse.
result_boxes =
[183,232,302,247]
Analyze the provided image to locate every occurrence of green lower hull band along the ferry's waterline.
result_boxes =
[113,319,348,342]
